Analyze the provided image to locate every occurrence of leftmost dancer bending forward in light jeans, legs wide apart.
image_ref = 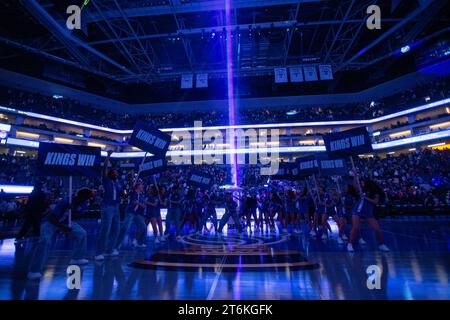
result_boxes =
[27,188,94,280]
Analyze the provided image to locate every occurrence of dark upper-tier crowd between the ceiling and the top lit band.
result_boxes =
[0,78,450,129]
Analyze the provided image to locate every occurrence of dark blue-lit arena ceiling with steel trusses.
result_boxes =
[0,0,450,101]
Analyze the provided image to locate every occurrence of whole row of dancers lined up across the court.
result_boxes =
[23,152,389,280]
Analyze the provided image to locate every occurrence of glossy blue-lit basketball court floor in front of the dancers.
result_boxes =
[0,220,450,300]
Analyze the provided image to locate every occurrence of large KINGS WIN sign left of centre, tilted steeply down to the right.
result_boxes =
[128,121,171,157]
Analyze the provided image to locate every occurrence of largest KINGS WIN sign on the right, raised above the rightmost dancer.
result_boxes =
[323,127,373,158]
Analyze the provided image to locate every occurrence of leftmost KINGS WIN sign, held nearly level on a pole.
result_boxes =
[36,142,102,177]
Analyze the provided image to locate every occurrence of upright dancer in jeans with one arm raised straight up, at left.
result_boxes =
[95,150,123,261]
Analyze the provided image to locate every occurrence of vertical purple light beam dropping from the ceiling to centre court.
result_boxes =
[225,0,238,186]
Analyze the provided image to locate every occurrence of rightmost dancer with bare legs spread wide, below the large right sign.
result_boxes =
[347,179,390,252]
